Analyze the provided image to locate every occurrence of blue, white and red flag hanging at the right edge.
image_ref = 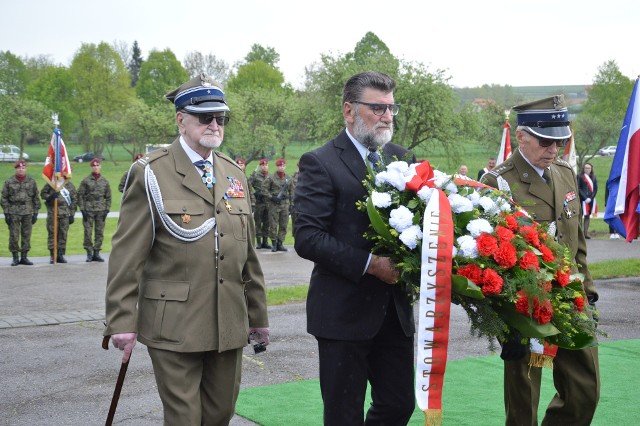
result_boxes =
[604,78,640,242]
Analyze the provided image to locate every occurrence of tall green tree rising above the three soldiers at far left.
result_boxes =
[69,42,133,153]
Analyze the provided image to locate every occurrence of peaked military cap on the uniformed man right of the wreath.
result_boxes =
[512,95,571,139]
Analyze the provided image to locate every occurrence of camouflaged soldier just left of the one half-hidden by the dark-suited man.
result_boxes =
[264,158,292,252]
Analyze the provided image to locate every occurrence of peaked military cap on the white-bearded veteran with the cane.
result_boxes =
[165,73,229,114]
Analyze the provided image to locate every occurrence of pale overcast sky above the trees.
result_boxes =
[0,0,640,87]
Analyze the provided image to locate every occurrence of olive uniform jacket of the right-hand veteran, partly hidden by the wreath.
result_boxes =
[481,149,597,300]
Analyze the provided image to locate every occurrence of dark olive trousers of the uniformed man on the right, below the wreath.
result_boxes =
[504,340,600,426]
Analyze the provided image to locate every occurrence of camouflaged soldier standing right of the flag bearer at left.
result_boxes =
[78,158,111,262]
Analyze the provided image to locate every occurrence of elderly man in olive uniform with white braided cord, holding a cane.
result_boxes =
[104,74,269,425]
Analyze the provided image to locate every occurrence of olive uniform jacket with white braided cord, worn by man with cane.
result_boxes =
[104,139,268,352]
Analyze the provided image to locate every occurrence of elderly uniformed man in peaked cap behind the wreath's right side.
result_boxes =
[482,95,600,425]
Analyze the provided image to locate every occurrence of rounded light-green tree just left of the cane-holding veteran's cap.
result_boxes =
[136,49,189,105]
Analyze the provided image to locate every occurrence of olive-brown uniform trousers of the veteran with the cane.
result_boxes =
[148,347,242,426]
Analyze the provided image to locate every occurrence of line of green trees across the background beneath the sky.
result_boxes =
[0,32,633,170]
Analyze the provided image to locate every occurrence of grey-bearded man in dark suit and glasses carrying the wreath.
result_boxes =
[294,72,415,425]
